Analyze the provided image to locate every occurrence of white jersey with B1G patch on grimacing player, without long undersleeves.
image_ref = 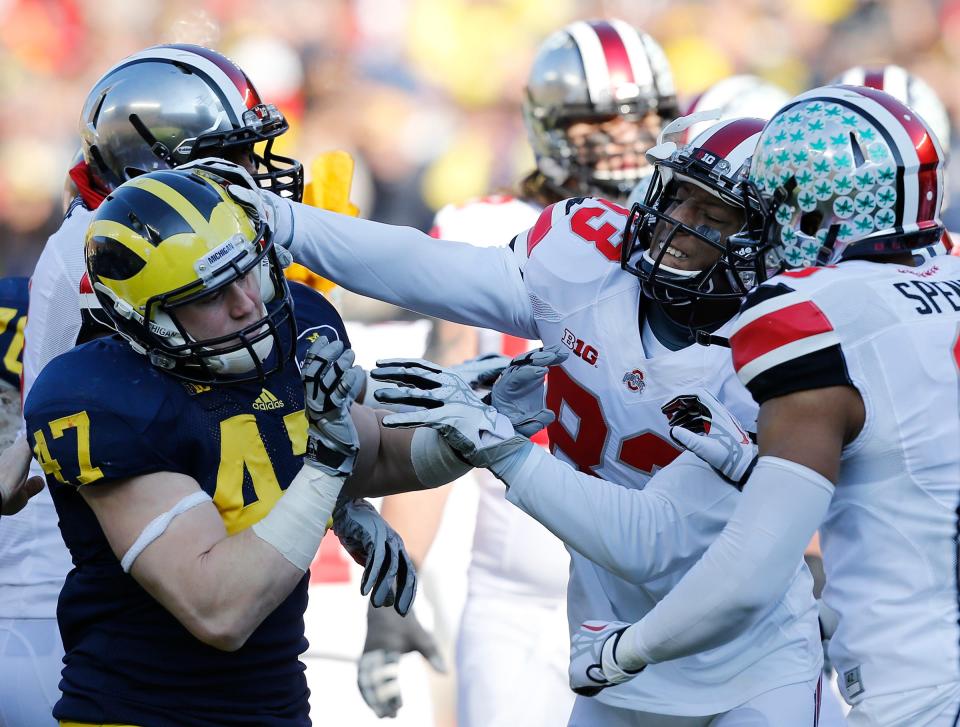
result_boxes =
[514,200,819,714]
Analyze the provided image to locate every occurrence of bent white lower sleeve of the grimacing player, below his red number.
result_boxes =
[507,448,737,585]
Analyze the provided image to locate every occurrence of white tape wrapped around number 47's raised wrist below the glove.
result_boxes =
[251,464,344,573]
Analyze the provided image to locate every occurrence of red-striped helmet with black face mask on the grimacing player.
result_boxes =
[620,118,764,306]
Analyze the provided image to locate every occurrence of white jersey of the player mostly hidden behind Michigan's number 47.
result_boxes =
[0,202,93,618]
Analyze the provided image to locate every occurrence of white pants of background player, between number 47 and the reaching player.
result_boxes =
[457,594,575,727]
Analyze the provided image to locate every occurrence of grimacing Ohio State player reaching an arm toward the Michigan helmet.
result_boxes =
[218,112,821,725]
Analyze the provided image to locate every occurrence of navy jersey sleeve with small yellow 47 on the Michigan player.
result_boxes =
[24,339,189,487]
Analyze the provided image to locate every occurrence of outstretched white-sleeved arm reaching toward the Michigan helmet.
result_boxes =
[278,202,537,338]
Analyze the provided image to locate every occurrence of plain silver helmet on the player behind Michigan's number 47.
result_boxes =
[80,44,303,201]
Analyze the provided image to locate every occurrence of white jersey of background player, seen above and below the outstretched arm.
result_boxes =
[430,195,569,599]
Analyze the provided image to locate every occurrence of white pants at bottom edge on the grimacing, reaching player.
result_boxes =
[568,679,820,727]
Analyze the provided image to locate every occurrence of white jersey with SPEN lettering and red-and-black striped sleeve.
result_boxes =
[731,256,960,703]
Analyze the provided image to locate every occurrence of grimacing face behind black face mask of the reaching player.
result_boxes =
[650,181,743,270]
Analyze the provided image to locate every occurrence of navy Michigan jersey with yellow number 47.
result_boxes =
[25,285,349,727]
